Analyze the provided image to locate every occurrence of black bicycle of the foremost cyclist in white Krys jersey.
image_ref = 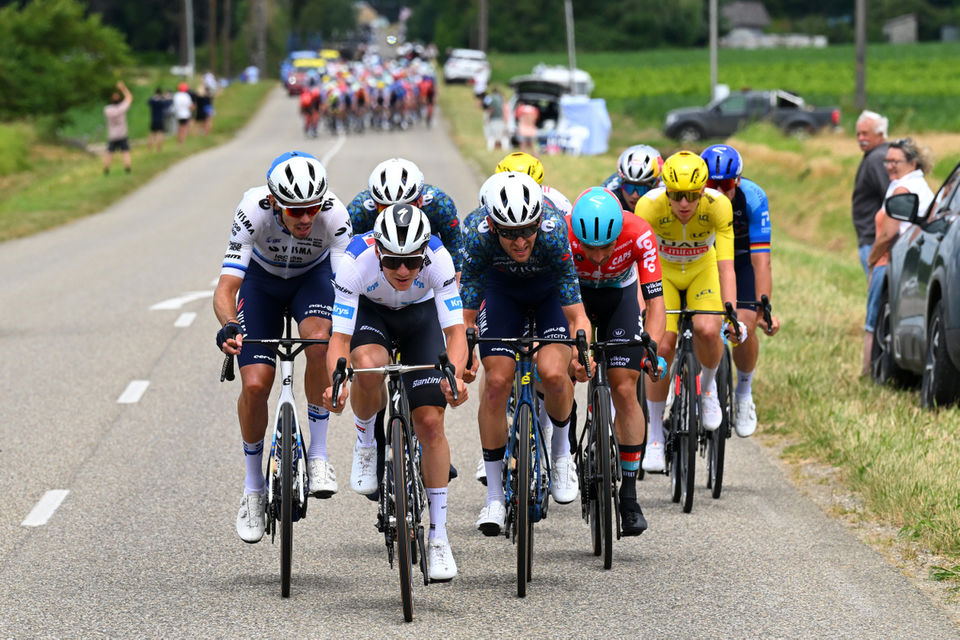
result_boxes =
[332,349,458,622]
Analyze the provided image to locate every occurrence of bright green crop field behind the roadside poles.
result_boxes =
[490,42,960,131]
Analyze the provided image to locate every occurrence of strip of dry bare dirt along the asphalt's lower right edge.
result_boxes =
[755,432,960,626]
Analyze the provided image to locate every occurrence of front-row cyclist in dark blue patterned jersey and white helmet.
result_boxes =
[460,171,590,536]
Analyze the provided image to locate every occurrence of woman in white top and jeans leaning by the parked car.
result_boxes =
[861,138,933,375]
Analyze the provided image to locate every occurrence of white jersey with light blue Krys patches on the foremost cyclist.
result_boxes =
[333,231,463,336]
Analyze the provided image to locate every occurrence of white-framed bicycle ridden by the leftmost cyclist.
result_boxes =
[220,310,328,598]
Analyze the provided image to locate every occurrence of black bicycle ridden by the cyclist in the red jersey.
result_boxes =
[576,332,657,569]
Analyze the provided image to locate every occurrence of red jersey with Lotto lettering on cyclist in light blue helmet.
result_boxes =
[567,211,662,299]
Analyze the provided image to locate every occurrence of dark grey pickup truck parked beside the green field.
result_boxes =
[663,89,840,142]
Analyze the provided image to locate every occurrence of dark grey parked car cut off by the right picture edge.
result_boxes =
[871,170,960,407]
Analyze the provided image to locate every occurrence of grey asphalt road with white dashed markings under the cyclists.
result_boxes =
[0,86,960,638]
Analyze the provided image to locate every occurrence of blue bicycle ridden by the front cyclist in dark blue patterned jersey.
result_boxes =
[467,317,589,598]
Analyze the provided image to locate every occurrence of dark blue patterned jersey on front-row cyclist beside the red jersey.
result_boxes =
[460,201,581,310]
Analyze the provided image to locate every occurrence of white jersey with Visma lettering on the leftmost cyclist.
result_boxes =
[220,186,353,279]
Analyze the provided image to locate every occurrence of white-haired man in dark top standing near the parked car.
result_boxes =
[851,111,890,278]
